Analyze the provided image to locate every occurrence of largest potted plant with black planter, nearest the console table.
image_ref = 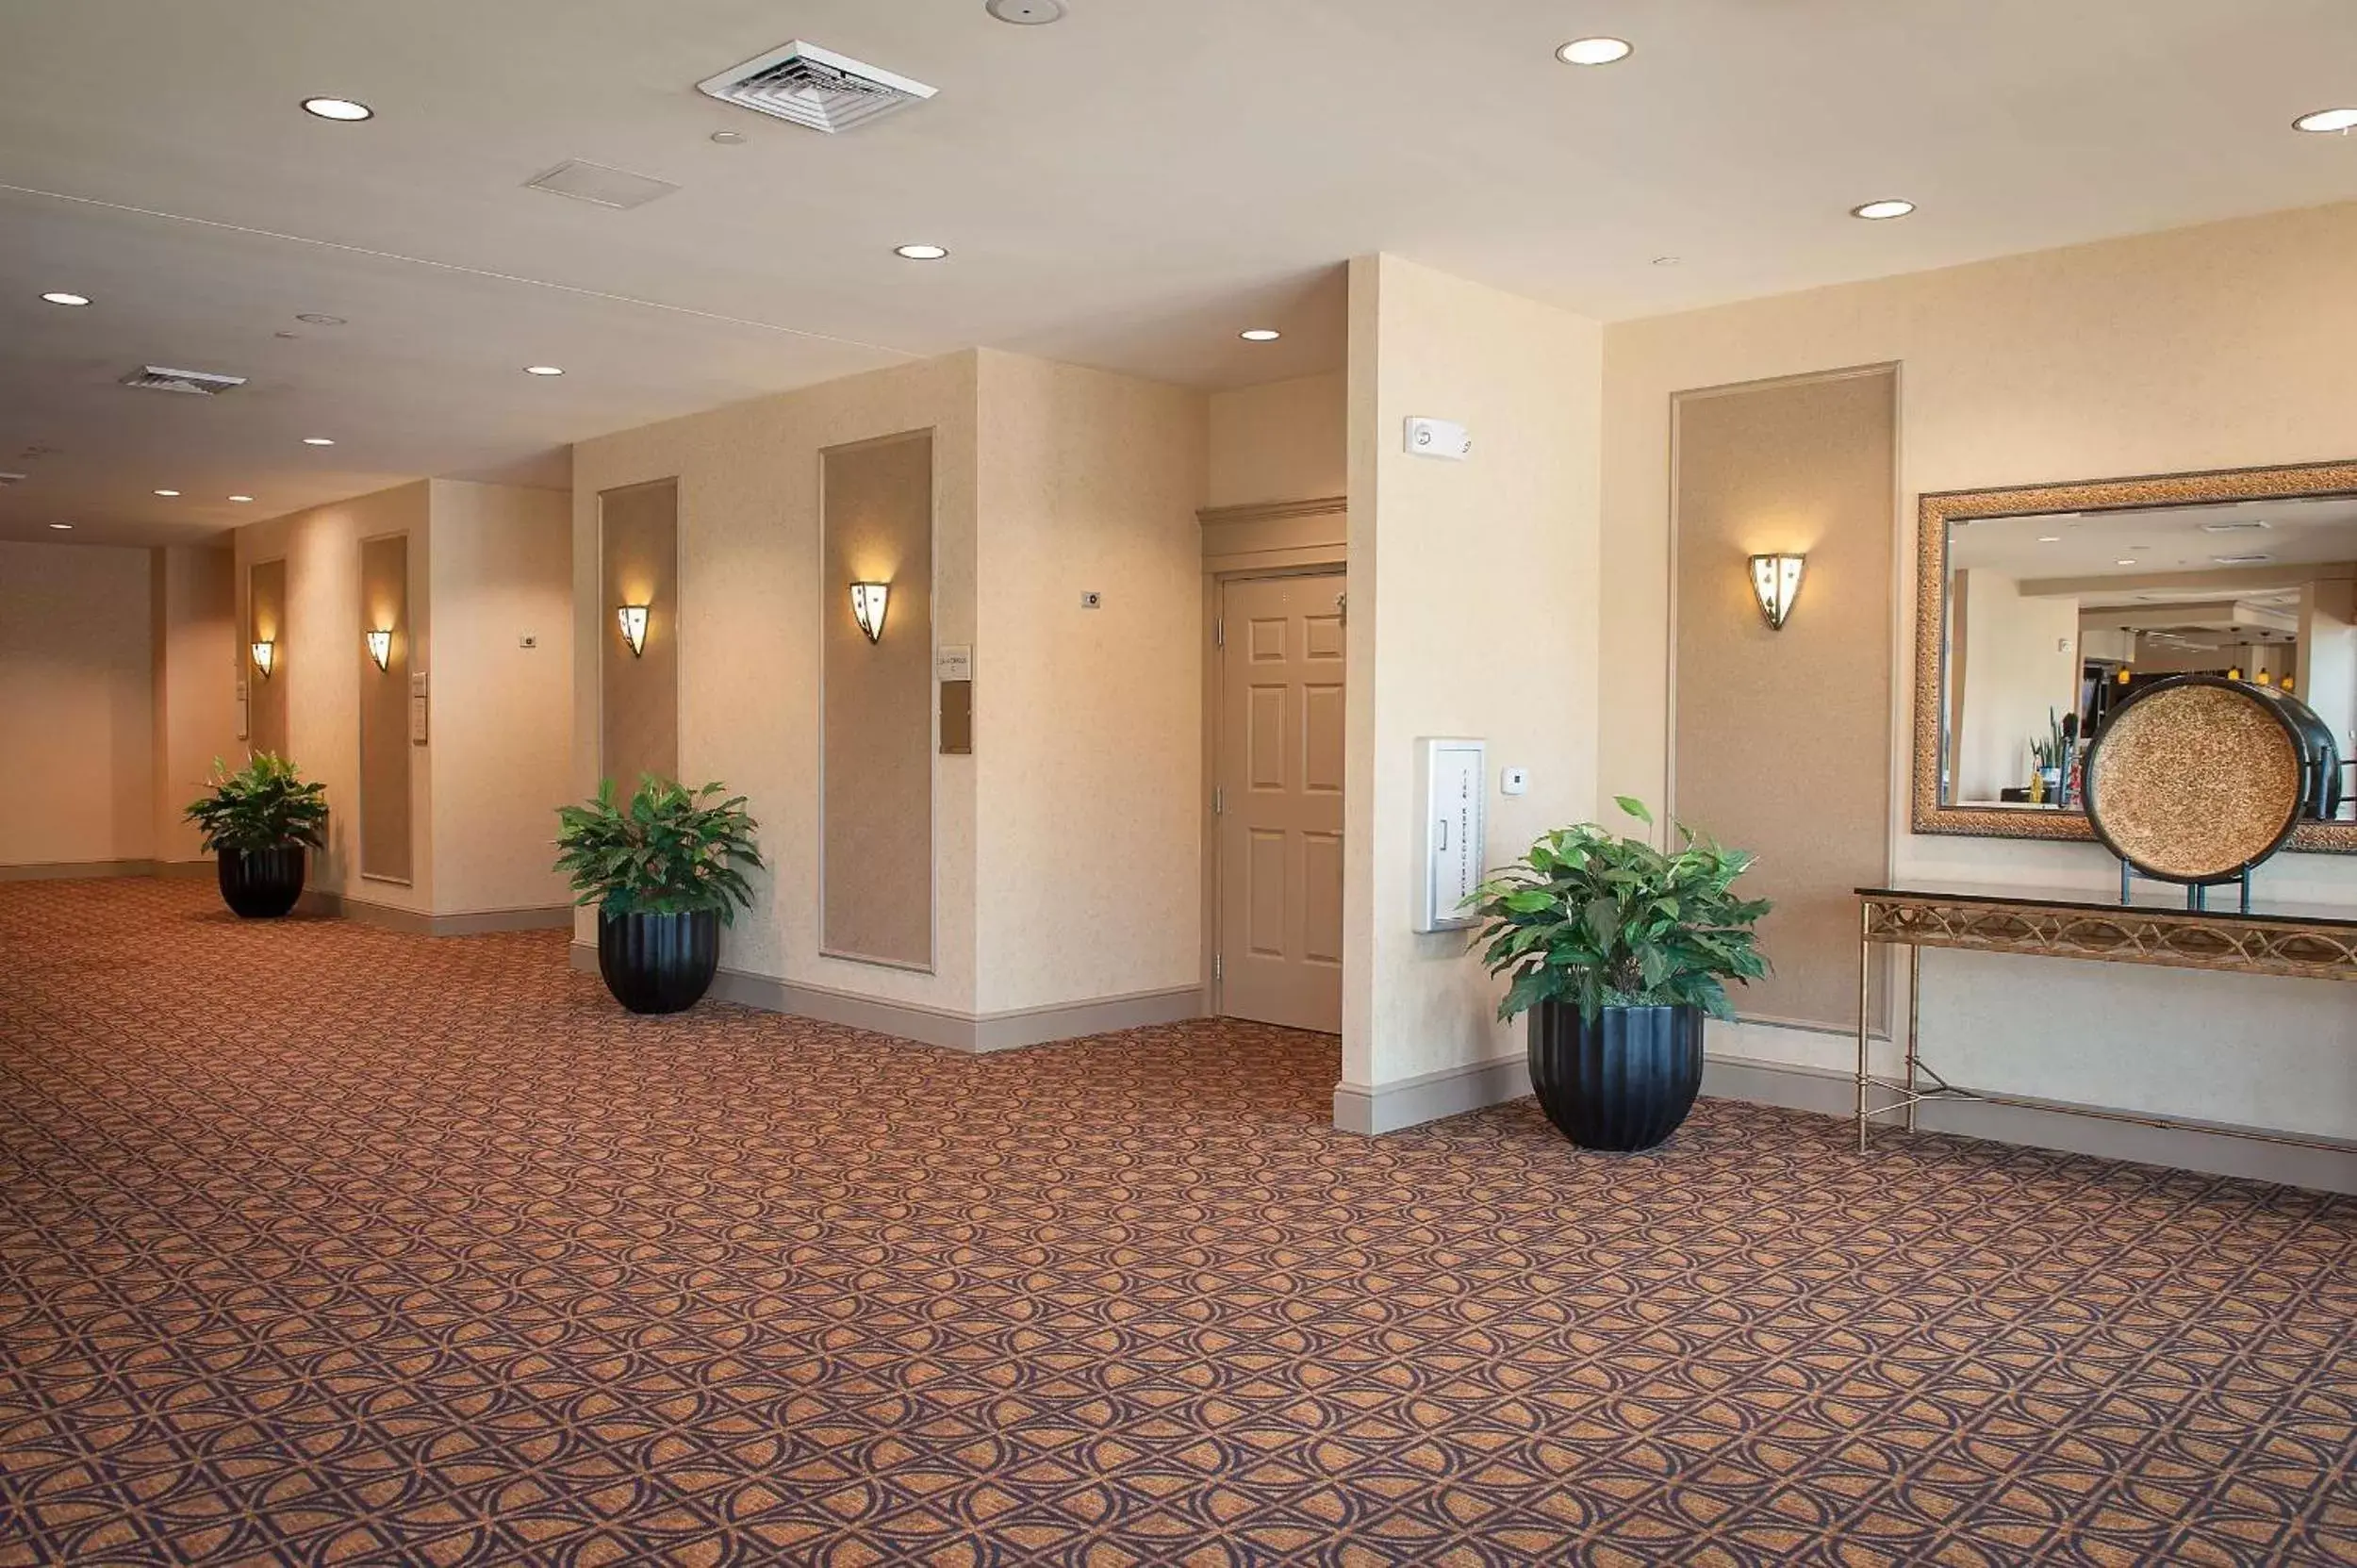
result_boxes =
[1466,795,1768,1150]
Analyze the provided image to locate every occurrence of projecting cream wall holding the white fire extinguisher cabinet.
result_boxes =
[1343,257,1603,1087]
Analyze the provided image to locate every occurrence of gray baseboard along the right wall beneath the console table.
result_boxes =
[1702,1056,2357,1193]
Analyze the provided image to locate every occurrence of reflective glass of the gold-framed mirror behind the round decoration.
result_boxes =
[1940,495,2357,820]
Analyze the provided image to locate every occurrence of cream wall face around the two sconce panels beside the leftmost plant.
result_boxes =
[236,479,434,915]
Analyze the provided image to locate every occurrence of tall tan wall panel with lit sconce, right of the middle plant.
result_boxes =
[818,429,933,969]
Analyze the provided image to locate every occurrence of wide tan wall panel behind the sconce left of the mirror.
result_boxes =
[1672,366,1898,1028]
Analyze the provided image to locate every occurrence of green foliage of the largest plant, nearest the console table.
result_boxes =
[1466,795,1771,1021]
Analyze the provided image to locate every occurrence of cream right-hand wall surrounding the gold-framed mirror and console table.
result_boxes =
[1603,206,2357,1136]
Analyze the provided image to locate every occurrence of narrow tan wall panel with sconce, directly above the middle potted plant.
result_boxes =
[597,479,679,797]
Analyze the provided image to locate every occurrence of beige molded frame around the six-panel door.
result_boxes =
[1195,495,1351,1018]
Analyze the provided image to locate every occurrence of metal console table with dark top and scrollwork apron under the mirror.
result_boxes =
[1857,884,2357,1153]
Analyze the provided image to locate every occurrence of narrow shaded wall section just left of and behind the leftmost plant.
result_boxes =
[149,545,240,861]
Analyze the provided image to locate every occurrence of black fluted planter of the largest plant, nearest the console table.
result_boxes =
[1530,1002,1702,1150]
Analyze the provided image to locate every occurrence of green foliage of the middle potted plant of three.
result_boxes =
[556,773,762,922]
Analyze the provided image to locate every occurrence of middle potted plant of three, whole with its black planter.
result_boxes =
[556,773,762,1014]
